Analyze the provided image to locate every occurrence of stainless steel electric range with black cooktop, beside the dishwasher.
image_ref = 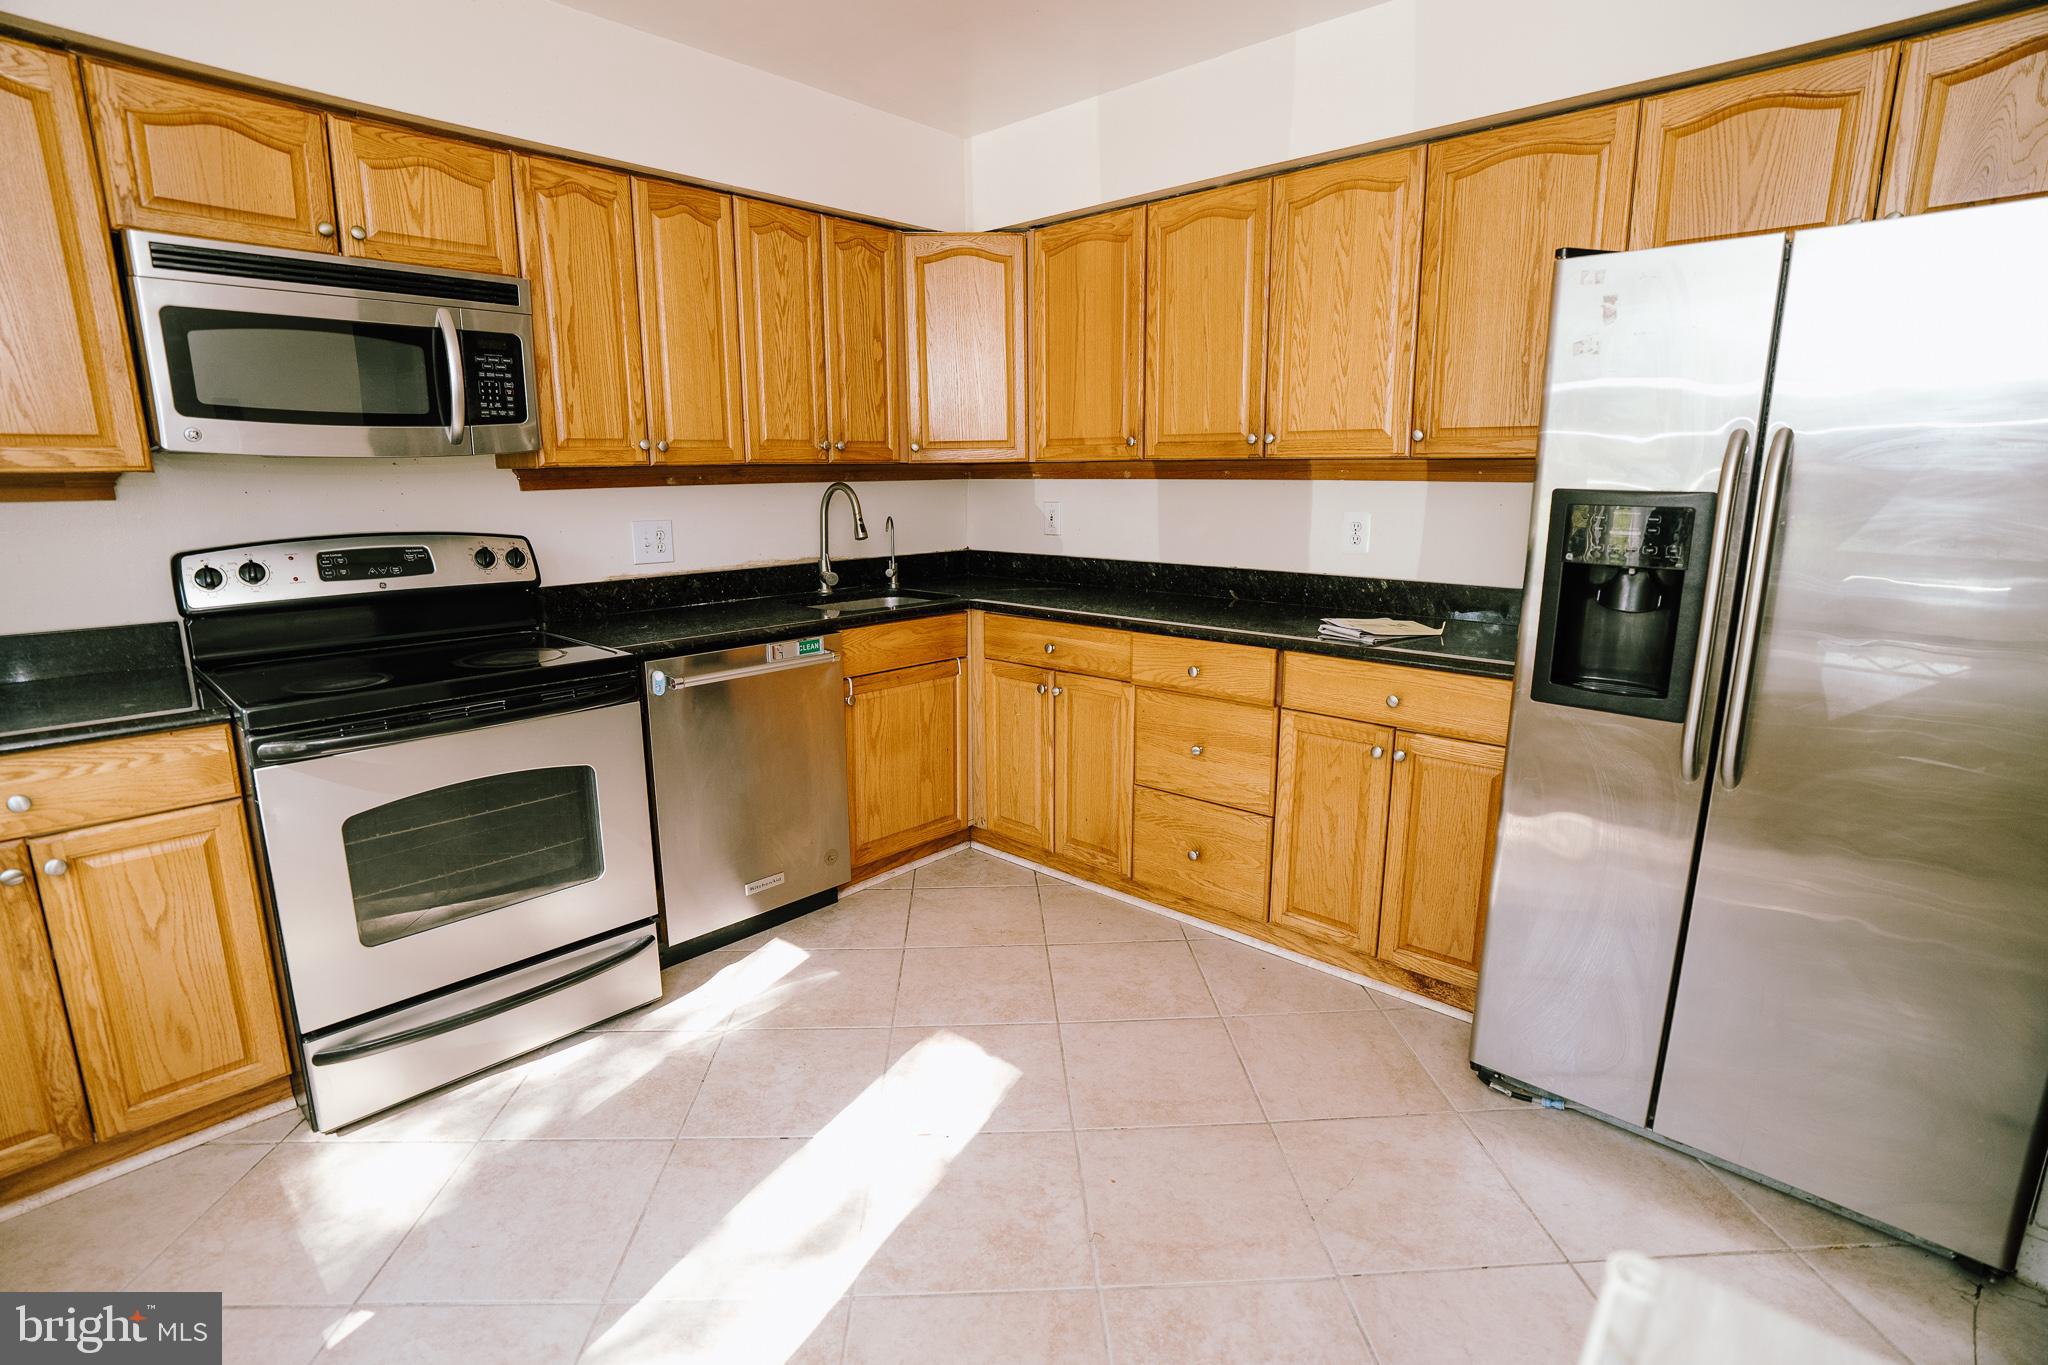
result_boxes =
[172,534,662,1130]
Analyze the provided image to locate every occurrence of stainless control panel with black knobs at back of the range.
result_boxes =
[170,532,541,616]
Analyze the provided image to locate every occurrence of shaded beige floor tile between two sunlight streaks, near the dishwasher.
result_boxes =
[682,1029,889,1138]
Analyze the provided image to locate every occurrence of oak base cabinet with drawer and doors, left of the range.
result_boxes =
[0,726,289,1175]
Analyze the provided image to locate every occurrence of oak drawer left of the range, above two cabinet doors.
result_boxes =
[0,724,242,839]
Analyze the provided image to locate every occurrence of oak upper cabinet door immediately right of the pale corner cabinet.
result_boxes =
[1028,205,1145,460]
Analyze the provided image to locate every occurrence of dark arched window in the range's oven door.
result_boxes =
[342,767,604,948]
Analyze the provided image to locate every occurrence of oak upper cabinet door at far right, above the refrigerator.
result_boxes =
[1878,10,2048,215]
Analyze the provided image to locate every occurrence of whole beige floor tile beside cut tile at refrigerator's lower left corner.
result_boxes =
[1229,1009,1450,1124]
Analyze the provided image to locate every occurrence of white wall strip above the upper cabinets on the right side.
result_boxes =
[967,0,1950,227]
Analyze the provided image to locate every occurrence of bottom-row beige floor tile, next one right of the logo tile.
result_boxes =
[317,1304,598,1365]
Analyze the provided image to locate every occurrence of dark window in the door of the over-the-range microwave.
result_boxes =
[158,305,449,426]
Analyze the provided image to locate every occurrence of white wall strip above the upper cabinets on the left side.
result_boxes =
[0,0,967,229]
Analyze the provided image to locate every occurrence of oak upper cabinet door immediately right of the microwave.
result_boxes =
[516,156,653,465]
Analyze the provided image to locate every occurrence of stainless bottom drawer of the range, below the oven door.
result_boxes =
[305,923,662,1132]
